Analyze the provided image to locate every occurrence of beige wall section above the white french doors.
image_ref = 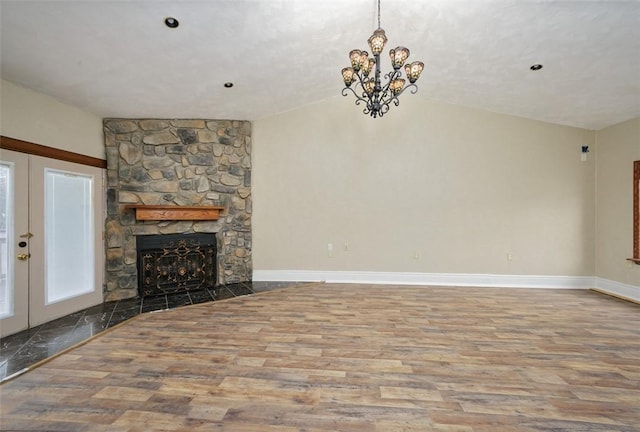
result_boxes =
[0,80,105,159]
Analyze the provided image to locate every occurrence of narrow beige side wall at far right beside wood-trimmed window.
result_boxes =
[596,118,640,286]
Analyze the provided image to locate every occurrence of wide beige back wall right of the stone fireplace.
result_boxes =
[252,95,595,276]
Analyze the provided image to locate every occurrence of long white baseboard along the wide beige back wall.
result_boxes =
[253,270,596,289]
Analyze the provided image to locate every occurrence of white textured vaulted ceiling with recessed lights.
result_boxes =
[0,0,640,130]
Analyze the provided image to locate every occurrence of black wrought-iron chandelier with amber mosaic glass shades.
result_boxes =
[342,0,424,118]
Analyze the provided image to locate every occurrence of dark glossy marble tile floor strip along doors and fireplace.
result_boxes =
[0,282,299,382]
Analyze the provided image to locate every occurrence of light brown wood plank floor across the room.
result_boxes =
[0,284,640,432]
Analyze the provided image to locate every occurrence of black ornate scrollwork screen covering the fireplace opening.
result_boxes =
[136,233,217,297]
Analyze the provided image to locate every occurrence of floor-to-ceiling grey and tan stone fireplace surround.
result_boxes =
[104,119,252,301]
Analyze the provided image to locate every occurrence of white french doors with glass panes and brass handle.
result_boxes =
[0,150,104,336]
